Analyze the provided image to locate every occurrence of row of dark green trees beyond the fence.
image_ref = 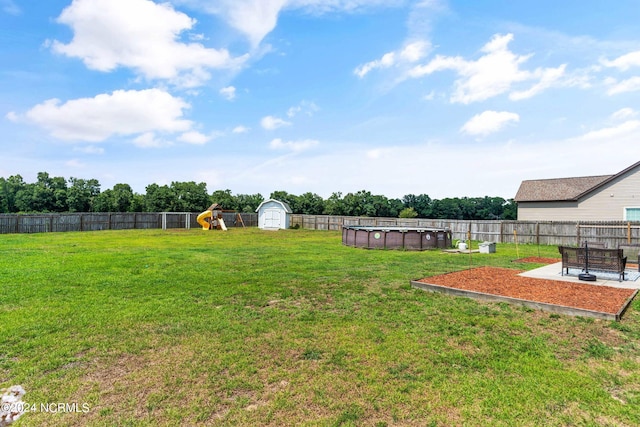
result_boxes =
[0,172,517,220]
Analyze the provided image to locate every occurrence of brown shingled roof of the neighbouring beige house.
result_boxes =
[514,162,640,202]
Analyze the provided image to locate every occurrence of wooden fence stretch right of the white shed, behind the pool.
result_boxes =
[291,214,640,248]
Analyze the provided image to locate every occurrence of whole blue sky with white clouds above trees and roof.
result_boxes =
[0,0,640,199]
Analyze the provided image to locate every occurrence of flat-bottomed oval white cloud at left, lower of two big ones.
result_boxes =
[17,89,192,142]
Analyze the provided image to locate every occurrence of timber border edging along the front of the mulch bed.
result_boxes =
[410,280,638,322]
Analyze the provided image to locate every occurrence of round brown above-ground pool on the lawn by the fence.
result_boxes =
[342,226,451,251]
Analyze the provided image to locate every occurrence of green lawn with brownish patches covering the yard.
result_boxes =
[0,229,640,426]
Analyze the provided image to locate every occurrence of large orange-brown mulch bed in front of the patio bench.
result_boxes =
[417,267,635,314]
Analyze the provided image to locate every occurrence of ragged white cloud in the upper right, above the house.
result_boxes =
[408,34,565,104]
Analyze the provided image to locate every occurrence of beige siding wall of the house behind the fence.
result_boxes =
[518,167,640,221]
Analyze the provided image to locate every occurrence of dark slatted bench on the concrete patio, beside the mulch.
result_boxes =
[558,246,627,282]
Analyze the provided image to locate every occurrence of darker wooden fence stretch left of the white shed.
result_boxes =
[0,212,258,234]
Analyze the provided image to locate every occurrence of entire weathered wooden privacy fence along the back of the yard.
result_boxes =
[0,212,640,248]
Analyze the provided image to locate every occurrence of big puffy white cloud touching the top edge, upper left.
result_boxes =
[51,0,246,87]
